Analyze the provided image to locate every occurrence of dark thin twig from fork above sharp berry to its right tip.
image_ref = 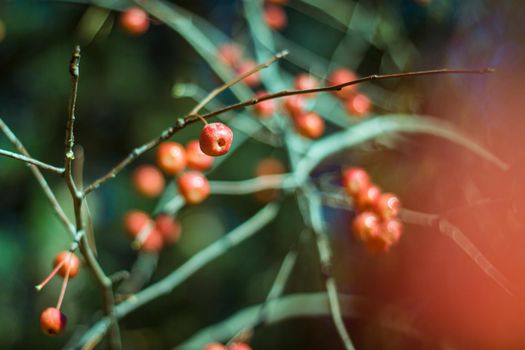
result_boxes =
[202,68,495,118]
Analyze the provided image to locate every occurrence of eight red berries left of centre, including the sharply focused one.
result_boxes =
[124,123,233,252]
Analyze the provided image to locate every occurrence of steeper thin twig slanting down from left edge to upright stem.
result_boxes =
[0,118,75,235]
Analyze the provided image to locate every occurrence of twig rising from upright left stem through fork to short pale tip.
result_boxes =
[84,51,287,196]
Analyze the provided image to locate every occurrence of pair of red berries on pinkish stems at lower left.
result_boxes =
[36,251,80,335]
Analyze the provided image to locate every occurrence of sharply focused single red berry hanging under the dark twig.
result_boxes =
[199,123,233,157]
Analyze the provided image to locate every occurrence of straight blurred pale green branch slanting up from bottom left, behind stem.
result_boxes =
[72,203,279,349]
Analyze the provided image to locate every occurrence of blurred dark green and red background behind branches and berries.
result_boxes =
[0,0,525,349]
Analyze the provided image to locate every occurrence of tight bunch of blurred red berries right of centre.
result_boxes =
[342,167,403,254]
